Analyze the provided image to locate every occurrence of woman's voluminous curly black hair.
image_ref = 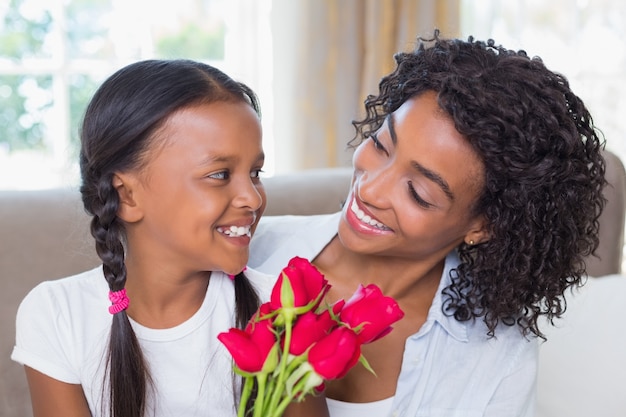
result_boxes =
[351,31,606,337]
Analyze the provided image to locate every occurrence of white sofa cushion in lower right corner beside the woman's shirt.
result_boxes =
[535,275,626,417]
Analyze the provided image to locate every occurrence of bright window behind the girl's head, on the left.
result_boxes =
[0,0,272,189]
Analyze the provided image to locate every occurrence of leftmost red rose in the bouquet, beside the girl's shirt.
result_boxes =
[217,303,278,373]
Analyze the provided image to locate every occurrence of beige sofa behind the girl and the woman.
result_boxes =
[0,154,626,417]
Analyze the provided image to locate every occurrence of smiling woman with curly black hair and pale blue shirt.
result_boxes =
[250,32,605,417]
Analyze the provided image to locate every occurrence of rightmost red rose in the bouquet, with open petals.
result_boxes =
[339,284,404,343]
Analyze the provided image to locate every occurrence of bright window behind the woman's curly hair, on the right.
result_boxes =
[461,0,626,163]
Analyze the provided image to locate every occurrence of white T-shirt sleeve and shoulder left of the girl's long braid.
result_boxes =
[11,267,111,384]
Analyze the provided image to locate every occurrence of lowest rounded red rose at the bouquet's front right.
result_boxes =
[308,327,361,379]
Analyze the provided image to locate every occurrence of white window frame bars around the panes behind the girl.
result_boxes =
[0,0,274,189]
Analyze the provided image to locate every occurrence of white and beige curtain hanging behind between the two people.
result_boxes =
[271,0,459,173]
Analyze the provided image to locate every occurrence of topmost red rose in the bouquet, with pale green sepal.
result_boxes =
[270,257,330,310]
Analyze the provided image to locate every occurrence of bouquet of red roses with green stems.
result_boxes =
[218,257,404,417]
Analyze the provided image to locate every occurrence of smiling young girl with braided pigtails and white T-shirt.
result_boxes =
[12,60,272,417]
